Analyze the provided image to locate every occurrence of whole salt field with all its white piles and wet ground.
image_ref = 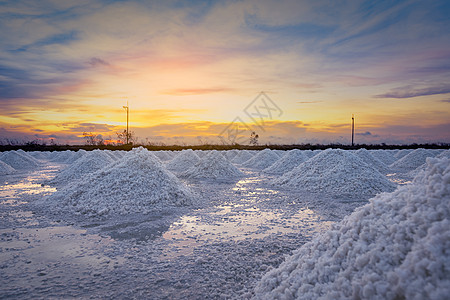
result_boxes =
[0,148,450,299]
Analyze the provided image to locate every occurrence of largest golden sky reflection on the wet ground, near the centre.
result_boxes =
[162,204,334,257]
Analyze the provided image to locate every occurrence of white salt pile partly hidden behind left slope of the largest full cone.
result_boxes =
[47,150,114,185]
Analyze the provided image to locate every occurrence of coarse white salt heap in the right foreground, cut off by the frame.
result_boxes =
[255,159,450,299]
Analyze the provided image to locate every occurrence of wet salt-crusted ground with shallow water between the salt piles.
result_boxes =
[0,163,398,299]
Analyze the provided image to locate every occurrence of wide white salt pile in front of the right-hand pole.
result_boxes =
[275,149,395,197]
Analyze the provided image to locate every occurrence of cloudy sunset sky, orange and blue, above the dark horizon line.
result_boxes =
[0,0,450,145]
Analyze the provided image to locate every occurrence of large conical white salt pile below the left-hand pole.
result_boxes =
[47,148,193,215]
